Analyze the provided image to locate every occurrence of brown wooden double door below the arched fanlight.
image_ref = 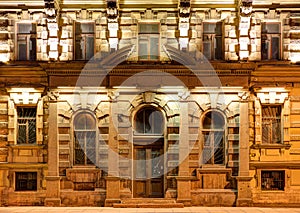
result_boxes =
[133,147,164,198]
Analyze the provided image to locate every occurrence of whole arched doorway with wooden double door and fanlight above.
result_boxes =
[133,106,164,198]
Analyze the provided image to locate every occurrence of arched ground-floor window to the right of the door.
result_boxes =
[202,111,225,164]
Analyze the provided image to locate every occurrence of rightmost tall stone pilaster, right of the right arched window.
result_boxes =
[236,100,252,206]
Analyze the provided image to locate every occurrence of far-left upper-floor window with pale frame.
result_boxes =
[17,23,36,61]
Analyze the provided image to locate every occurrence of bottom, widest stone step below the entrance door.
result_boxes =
[113,203,184,208]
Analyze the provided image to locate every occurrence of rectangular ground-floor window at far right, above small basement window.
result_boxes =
[262,105,281,144]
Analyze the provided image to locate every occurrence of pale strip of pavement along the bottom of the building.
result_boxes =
[0,206,300,213]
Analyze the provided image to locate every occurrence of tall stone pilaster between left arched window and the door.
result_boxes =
[105,102,120,207]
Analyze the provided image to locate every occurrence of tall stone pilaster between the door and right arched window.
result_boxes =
[176,101,191,206]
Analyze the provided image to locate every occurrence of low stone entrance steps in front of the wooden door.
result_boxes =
[113,198,184,208]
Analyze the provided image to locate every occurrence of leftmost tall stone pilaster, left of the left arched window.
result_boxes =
[45,101,61,206]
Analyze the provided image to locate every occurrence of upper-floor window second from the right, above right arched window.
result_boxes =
[203,22,223,60]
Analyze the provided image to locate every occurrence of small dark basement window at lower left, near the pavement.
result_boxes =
[16,172,37,191]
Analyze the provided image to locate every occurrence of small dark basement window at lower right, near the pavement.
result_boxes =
[261,171,285,190]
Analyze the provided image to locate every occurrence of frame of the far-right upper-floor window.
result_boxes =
[261,21,282,61]
